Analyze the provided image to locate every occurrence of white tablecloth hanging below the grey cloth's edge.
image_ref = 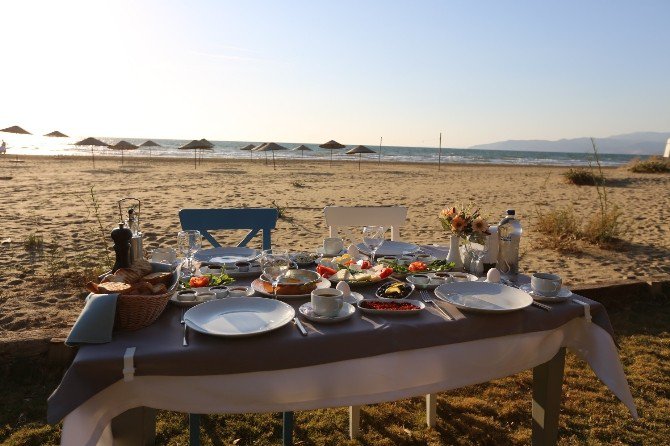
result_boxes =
[61,318,637,446]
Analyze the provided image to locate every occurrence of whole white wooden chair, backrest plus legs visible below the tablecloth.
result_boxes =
[323,206,437,439]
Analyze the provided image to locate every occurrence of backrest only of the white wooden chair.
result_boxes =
[323,206,407,242]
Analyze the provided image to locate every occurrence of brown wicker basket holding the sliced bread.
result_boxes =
[114,263,179,331]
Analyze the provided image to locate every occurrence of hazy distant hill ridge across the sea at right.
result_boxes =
[469,132,670,155]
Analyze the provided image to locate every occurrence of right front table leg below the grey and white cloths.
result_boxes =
[532,348,565,446]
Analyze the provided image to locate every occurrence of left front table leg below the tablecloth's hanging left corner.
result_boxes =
[112,407,157,446]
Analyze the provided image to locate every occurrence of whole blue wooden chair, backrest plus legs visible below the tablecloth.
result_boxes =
[179,208,293,446]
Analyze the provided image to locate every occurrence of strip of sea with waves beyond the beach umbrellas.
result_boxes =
[0,133,636,166]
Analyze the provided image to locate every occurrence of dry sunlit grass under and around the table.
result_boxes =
[0,296,670,446]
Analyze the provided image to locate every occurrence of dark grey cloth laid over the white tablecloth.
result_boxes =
[47,253,613,423]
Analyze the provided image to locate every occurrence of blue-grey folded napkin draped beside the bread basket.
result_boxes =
[65,294,119,347]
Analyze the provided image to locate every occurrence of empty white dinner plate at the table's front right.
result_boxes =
[435,282,533,313]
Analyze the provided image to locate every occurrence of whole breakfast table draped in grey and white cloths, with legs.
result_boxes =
[47,246,637,446]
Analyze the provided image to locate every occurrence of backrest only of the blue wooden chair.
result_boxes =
[179,208,279,249]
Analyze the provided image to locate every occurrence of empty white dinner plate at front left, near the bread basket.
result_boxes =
[184,297,295,337]
